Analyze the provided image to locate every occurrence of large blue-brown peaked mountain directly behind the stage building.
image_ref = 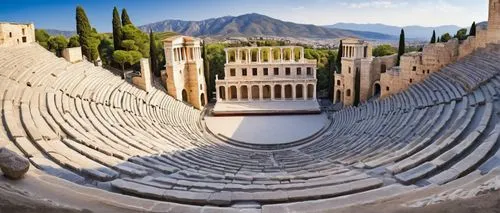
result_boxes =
[139,13,397,40]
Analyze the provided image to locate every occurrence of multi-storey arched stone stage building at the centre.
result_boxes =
[216,46,317,114]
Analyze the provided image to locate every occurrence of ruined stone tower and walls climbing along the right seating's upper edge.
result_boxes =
[334,0,500,105]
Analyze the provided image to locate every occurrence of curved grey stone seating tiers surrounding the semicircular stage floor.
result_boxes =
[0,44,500,212]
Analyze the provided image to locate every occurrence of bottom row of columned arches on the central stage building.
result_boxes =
[216,83,316,101]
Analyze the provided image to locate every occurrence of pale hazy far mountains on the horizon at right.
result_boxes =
[324,22,487,40]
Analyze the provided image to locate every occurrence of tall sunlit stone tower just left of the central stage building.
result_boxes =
[163,36,208,109]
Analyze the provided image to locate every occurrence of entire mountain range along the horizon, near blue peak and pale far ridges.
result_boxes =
[46,13,488,41]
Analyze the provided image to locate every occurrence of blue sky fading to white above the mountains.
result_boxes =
[0,0,488,32]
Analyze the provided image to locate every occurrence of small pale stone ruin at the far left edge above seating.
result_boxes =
[0,22,35,46]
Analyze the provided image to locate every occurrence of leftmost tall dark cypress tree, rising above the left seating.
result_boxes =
[76,6,92,61]
